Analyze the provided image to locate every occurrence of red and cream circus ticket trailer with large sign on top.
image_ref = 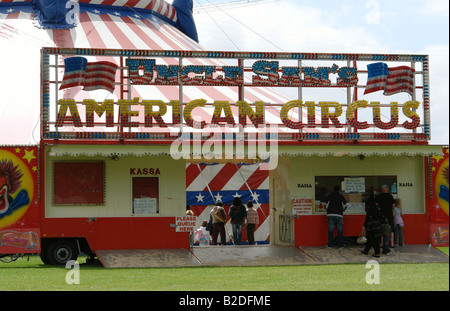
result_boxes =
[5,48,443,263]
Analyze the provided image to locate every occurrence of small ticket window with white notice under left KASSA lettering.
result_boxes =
[133,177,159,215]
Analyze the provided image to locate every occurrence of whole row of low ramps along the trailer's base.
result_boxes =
[96,245,449,268]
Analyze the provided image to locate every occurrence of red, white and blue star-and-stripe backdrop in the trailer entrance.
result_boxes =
[186,163,270,244]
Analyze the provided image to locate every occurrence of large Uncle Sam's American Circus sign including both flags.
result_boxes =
[41,48,430,141]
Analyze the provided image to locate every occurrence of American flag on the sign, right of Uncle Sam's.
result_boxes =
[364,63,415,96]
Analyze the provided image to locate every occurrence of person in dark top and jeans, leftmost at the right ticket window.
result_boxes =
[327,186,347,249]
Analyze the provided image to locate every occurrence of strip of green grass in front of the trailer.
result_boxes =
[0,254,449,291]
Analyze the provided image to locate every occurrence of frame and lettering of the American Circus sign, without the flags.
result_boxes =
[41,48,431,141]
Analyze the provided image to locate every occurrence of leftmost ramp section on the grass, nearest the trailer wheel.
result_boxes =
[96,249,201,268]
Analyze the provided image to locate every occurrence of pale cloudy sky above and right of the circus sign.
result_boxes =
[193,0,449,145]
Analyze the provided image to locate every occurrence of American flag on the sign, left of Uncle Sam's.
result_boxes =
[59,57,118,93]
